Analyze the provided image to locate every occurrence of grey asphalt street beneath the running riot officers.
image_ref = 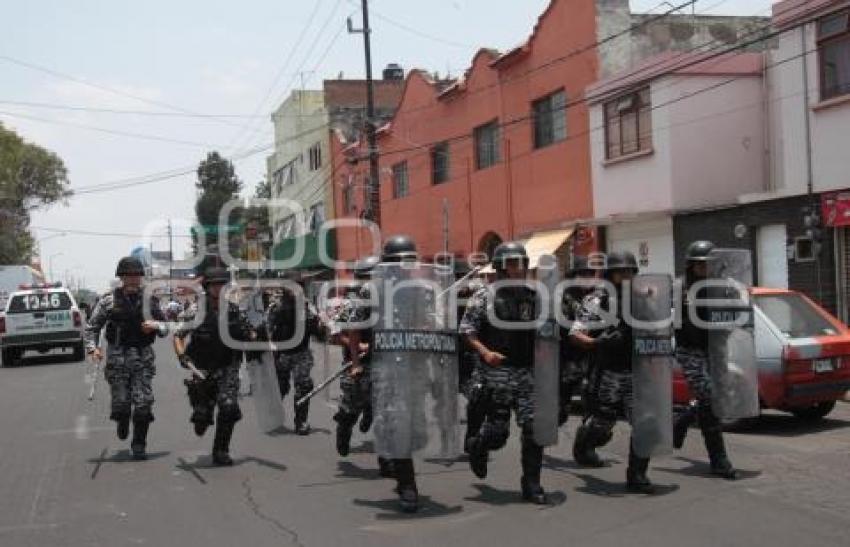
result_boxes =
[0,340,850,547]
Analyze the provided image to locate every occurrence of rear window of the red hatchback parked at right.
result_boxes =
[755,294,838,338]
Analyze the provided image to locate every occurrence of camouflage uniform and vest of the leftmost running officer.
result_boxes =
[85,289,168,421]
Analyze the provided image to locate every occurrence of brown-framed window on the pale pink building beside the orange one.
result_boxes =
[605,87,652,160]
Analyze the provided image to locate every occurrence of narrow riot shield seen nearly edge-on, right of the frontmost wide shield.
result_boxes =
[534,255,561,446]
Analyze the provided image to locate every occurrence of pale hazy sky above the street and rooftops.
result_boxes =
[0,0,772,290]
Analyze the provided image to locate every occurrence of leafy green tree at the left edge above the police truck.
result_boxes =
[0,123,71,264]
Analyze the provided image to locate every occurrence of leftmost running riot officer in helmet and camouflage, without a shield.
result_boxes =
[85,256,168,460]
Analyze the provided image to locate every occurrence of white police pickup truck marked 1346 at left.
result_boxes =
[0,283,85,367]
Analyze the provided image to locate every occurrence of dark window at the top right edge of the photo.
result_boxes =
[818,11,850,101]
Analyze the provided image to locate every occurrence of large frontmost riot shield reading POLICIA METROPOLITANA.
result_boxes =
[369,263,460,458]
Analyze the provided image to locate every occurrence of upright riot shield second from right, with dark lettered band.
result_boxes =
[624,274,674,458]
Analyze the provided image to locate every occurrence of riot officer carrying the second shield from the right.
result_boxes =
[570,251,654,494]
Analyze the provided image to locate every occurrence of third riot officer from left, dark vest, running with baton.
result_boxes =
[265,280,323,435]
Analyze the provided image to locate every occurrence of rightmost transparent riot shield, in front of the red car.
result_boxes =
[706,249,760,421]
